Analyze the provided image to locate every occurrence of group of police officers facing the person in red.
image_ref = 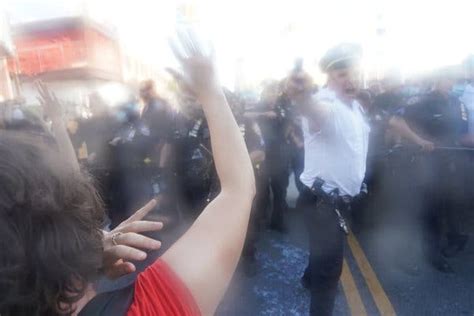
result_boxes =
[2,44,474,315]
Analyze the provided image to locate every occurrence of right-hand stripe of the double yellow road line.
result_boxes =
[347,233,396,316]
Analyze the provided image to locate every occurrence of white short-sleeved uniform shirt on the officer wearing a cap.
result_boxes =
[300,89,370,196]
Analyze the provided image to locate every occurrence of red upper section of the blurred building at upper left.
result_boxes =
[9,18,121,77]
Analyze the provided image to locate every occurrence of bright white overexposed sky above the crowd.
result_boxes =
[0,0,474,83]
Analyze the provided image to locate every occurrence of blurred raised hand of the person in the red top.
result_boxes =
[168,30,219,98]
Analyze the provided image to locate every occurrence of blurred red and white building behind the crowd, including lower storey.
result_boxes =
[0,16,163,115]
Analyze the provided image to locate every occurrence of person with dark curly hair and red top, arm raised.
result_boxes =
[0,28,255,316]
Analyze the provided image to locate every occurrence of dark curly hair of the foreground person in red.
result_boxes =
[0,131,104,316]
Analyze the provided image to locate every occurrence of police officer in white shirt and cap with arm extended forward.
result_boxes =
[290,44,370,316]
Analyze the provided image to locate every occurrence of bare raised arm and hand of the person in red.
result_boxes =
[162,33,255,315]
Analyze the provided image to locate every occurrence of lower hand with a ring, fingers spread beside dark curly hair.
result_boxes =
[103,199,163,279]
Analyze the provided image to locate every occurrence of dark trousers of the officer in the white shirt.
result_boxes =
[300,190,345,316]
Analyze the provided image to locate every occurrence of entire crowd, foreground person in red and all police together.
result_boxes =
[0,27,474,315]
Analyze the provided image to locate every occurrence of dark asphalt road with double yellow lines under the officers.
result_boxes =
[218,179,474,316]
